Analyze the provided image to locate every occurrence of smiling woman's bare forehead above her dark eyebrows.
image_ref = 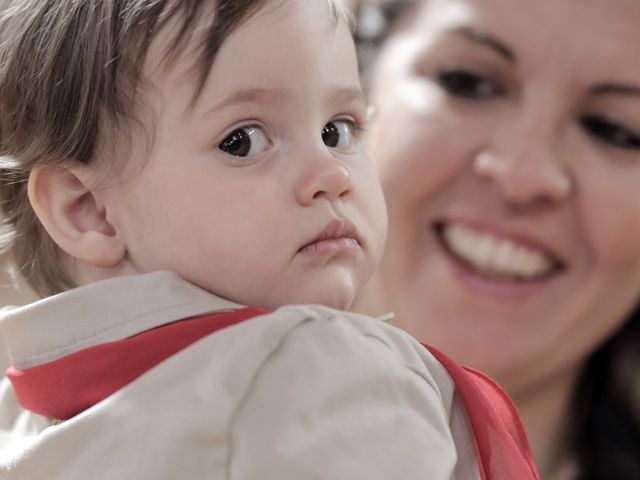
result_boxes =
[404,0,640,78]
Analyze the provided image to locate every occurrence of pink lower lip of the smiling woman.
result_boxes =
[436,232,562,301]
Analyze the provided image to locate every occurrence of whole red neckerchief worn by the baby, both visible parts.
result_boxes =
[7,308,539,480]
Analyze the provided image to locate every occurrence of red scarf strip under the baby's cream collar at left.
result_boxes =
[7,308,268,420]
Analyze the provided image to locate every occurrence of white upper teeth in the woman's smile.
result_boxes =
[443,225,554,280]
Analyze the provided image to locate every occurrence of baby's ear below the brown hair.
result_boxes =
[29,165,126,268]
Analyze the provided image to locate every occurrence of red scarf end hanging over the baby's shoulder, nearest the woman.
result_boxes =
[423,344,540,480]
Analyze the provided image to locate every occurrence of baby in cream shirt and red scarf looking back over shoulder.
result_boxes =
[0,0,536,480]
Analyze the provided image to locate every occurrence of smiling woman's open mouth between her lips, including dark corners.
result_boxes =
[434,222,565,282]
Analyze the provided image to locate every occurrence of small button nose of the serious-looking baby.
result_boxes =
[294,151,353,206]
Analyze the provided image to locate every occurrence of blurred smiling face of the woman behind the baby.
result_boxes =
[363,0,640,394]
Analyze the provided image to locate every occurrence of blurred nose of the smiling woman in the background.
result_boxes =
[474,123,573,206]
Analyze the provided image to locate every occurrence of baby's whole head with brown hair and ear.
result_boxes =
[0,0,386,308]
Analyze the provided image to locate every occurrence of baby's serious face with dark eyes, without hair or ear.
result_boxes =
[101,0,386,308]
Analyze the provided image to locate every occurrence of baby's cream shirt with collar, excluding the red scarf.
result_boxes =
[0,272,479,480]
